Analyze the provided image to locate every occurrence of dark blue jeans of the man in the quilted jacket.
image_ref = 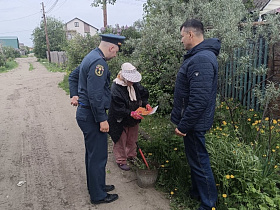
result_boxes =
[184,131,218,210]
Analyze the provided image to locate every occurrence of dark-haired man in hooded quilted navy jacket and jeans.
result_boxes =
[171,19,221,210]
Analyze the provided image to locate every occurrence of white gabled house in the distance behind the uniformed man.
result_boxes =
[65,17,98,40]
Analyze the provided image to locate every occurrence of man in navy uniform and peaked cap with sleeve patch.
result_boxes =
[69,34,125,204]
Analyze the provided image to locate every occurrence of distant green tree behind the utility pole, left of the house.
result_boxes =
[32,17,67,58]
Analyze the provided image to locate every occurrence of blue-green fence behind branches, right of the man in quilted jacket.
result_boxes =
[218,38,269,111]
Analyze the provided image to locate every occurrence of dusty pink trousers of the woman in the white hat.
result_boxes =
[113,124,139,164]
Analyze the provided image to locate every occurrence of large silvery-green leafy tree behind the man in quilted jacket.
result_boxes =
[133,0,279,113]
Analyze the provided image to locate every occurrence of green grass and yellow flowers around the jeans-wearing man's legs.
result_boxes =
[139,107,280,210]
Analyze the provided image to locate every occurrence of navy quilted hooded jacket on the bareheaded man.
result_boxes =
[171,39,221,133]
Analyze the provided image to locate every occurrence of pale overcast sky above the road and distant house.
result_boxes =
[0,0,146,47]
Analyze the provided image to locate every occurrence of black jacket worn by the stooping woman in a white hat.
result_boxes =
[108,82,149,142]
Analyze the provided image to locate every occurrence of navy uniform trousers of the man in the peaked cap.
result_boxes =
[76,107,108,201]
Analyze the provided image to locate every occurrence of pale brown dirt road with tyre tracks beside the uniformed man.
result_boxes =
[0,57,170,210]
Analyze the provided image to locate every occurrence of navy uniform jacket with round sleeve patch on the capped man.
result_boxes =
[69,48,111,122]
